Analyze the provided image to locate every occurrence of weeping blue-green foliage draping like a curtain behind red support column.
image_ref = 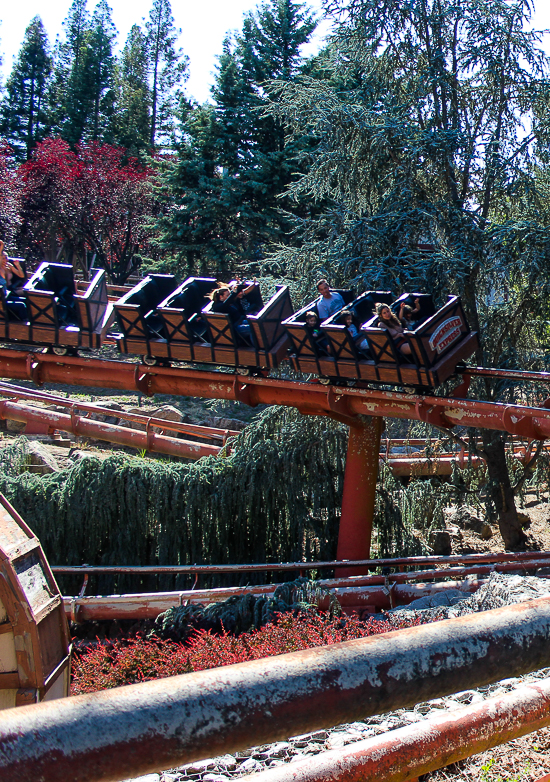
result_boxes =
[0,407,478,591]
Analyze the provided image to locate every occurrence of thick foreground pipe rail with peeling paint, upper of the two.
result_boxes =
[0,598,550,782]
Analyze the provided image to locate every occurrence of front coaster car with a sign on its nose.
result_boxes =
[285,291,478,388]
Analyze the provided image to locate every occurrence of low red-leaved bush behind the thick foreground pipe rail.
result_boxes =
[72,613,421,695]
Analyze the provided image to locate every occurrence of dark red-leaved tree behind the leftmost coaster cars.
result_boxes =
[19,139,155,284]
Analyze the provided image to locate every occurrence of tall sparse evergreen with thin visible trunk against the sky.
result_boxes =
[145,0,188,148]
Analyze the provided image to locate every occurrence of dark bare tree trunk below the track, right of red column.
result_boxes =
[483,429,527,551]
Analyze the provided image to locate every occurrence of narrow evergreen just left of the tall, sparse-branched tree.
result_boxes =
[116,24,150,155]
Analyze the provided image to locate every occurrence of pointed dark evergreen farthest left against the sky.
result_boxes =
[0,16,52,159]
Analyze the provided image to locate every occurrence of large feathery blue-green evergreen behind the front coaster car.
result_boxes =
[273,0,550,548]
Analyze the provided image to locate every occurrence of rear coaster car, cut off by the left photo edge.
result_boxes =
[0,263,114,355]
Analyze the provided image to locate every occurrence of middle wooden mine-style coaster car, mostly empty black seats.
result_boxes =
[114,275,298,373]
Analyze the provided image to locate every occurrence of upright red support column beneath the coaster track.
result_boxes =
[336,416,384,578]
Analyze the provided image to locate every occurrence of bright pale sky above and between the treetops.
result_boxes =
[0,0,550,103]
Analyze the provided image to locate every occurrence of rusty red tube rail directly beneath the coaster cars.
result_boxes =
[0,349,550,440]
